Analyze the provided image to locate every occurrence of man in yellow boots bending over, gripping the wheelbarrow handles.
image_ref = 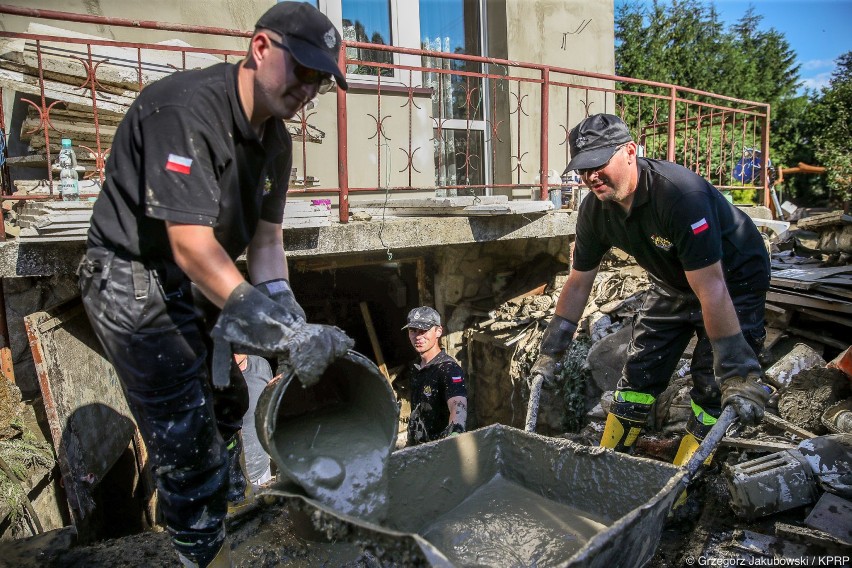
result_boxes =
[532,114,769,463]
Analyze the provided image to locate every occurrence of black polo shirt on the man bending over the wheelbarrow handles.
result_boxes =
[573,158,769,294]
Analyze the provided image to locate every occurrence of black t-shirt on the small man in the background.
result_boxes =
[408,350,467,446]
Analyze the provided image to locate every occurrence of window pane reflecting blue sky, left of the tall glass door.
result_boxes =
[341,0,393,77]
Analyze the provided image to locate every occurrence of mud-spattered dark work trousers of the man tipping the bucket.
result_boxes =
[79,248,248,566]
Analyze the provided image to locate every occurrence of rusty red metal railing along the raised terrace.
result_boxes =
[0,5,770,226]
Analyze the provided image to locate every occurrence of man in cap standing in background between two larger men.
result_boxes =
[402,306,467,446]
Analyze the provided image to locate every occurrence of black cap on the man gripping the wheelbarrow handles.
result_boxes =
[565,114,633,172]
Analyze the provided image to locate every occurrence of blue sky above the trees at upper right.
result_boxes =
[615,0,852,93]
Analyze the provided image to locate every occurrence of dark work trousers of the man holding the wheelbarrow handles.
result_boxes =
[618,278,766,417]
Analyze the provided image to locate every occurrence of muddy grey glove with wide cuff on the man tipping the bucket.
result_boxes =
[210,282,355,388]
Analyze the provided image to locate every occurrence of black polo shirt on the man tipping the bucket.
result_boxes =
[88,63,292,260]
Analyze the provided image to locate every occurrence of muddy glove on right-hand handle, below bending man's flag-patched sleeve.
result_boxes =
[712,333,771,424]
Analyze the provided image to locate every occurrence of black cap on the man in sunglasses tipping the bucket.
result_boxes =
[254,2,349,91]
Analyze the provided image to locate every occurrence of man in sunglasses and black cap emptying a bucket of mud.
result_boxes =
[79,2,353,566]
